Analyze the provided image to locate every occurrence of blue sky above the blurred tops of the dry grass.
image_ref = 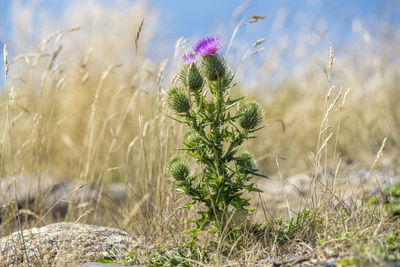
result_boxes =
[0,0,400,86]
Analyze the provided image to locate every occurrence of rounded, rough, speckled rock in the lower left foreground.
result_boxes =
[0,223,139,266]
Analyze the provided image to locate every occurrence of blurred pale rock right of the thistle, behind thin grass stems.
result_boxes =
[251,167,400,222]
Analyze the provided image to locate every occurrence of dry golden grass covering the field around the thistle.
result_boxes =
[0,1,400,266]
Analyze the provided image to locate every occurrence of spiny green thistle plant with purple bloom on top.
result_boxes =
[168,36,266,249]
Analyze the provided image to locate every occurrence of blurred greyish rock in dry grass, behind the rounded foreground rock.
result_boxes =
[0,175,126,222]
